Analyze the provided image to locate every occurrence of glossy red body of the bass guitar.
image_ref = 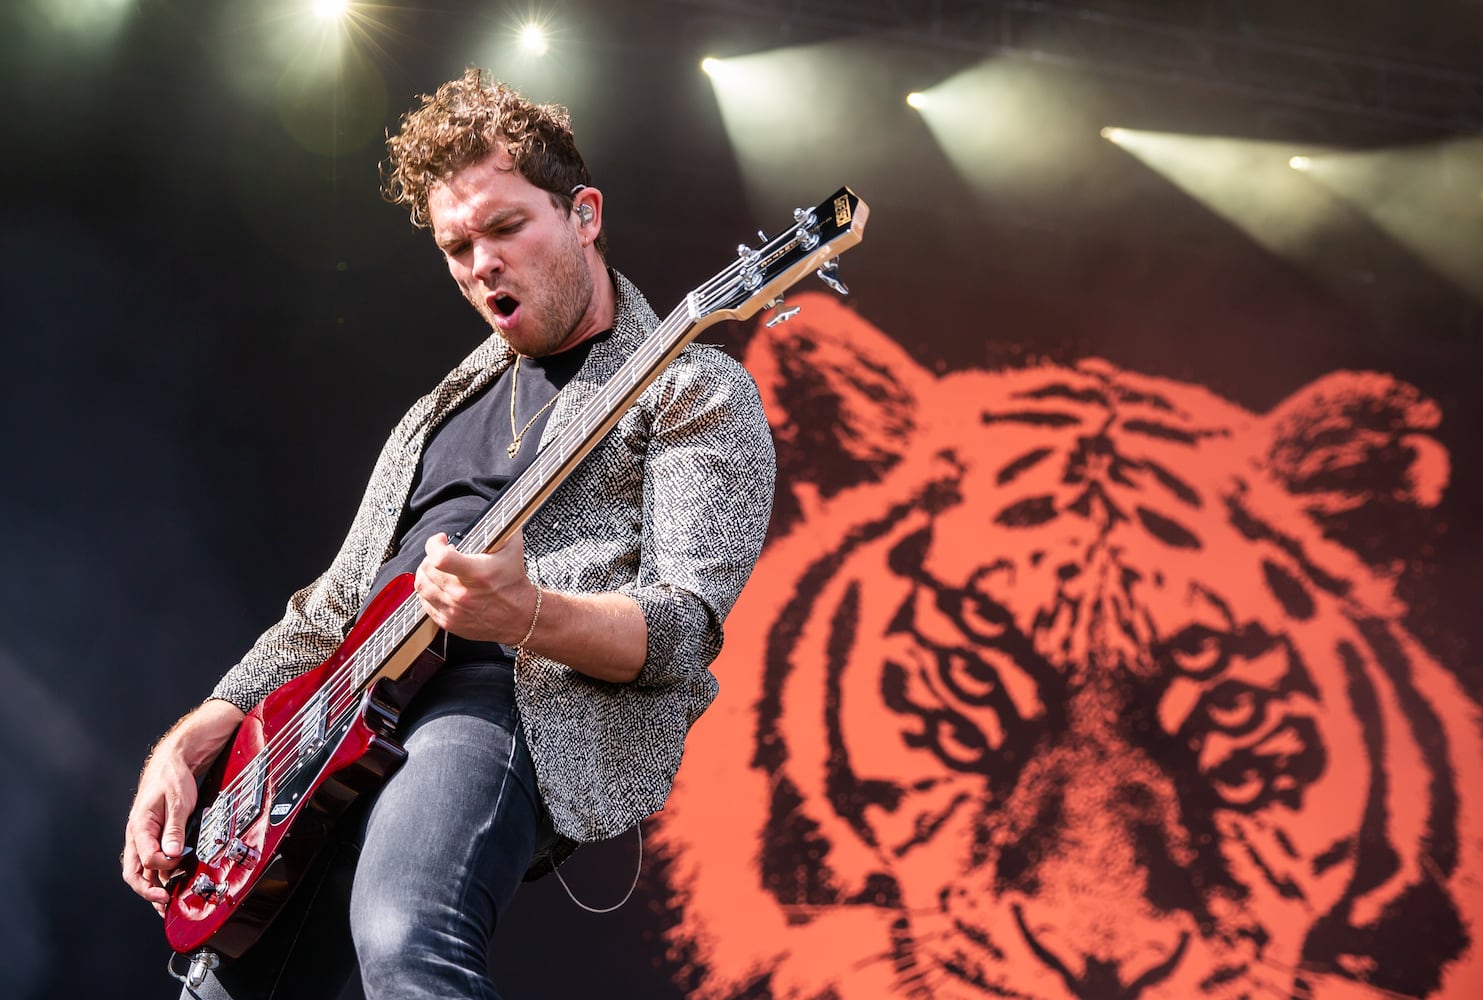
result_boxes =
[165,576,442,957]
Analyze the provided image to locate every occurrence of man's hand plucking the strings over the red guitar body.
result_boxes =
[119,699,243,915]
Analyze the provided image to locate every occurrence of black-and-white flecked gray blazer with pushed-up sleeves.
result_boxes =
[212,272,774,841]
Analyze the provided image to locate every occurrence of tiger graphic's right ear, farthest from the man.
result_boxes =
[1266,371,1452,567]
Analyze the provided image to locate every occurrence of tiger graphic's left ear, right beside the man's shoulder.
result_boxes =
[744,292,933,528]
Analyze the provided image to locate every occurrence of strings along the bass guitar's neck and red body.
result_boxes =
[208,219,830,835]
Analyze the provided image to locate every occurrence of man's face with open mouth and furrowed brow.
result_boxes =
[427,150,601,358]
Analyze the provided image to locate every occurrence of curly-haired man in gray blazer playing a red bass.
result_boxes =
[122,70,774,1000]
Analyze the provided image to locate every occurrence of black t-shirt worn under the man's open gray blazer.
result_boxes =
[362,334,607,653]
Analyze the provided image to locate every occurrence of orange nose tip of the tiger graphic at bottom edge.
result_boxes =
[1013,904,1189,1000]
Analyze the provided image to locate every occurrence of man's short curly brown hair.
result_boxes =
[381,67,607,252]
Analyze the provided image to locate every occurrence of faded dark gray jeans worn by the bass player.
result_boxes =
[181,663,550,1000]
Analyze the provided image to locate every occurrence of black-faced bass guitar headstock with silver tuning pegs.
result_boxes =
[690,187,871,323]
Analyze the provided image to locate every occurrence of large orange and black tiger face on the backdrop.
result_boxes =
[658,297,1483,1000]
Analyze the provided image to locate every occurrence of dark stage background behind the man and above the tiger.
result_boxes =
[0,0,1483,999]
